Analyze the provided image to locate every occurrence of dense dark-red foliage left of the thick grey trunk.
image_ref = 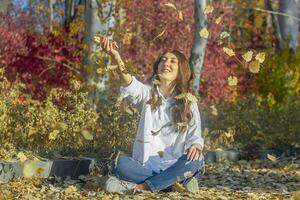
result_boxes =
[0,14,82,100]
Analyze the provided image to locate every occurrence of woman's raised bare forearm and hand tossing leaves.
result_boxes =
[101,37,132,86]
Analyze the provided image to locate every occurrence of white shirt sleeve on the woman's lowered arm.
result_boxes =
[185,103,204,150]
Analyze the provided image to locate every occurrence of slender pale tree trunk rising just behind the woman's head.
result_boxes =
[190,0,208,92]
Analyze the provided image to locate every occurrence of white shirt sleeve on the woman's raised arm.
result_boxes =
[120,76,150,111]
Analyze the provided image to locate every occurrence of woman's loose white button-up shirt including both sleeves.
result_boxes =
[121,77,203,172]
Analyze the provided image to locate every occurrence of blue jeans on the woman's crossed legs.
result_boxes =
[114,155,204,192]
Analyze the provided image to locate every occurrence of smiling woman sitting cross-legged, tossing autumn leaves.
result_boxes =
[102,38,204,193]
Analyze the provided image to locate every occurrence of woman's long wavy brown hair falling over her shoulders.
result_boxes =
[149,49,194,133]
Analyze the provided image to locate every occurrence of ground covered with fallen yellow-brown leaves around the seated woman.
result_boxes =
[0,157,300,200]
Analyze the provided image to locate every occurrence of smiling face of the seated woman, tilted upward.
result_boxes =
[158,52,179,82]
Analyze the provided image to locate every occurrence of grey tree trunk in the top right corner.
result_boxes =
[278,0,299,52]
